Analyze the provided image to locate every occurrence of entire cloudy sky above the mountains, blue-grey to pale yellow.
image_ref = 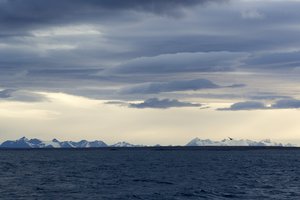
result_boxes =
[0,0,300,145]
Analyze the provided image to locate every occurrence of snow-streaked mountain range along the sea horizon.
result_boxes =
[0,137,295,149]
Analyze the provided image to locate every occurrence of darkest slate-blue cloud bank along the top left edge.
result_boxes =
[0,0,220,29]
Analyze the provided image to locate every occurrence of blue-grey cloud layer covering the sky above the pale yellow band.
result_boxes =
[0,0,300,106]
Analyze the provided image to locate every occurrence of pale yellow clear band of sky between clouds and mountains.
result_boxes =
[0,92,300,145]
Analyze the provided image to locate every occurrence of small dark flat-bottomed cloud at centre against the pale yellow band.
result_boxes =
[129,98,202,109]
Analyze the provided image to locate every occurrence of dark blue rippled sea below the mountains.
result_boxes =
[0,148,300,200]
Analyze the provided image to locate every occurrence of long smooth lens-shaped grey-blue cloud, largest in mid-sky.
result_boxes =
[109,51,247,74]
